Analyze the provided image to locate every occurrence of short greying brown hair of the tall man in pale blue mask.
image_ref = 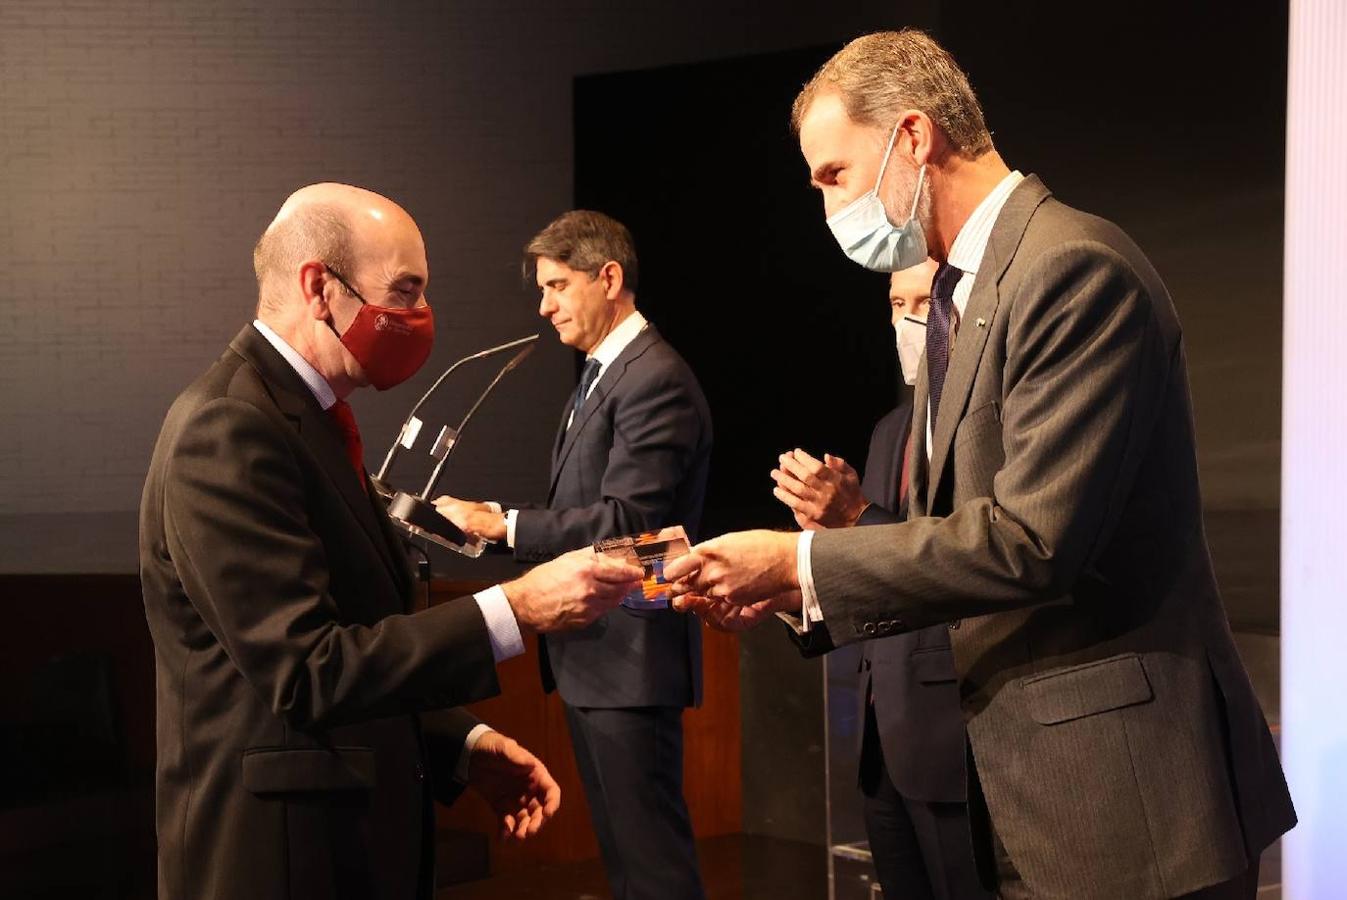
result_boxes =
[791,28,993,159]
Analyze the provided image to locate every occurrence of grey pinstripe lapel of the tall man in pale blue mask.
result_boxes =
[923,175,1049,509]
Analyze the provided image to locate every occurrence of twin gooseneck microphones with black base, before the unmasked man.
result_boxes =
[370,334,539,558]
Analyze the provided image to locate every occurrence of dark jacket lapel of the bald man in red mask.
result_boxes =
[230,325,407,590]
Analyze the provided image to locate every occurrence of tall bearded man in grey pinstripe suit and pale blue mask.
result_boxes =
[667,31,1294,900]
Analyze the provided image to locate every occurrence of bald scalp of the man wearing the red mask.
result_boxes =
[253,182,420,311]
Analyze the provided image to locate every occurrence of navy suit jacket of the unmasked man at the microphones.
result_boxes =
[515,326,711,709]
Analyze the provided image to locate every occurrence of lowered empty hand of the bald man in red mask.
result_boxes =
[467,732,562,839]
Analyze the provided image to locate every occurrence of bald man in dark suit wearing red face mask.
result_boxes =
[140,185,640,900]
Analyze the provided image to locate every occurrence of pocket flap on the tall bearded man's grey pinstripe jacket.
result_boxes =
[1024,653,1154,725]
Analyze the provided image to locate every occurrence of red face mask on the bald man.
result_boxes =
[327,267,435,391]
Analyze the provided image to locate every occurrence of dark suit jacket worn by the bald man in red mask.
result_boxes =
[140,326,498,900]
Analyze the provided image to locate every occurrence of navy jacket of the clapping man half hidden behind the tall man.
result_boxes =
[857,399,966,803]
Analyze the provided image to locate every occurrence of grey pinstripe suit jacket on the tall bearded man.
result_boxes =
[812,176,1294,900]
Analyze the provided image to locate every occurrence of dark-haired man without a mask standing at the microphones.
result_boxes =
[436,210,711,900]
